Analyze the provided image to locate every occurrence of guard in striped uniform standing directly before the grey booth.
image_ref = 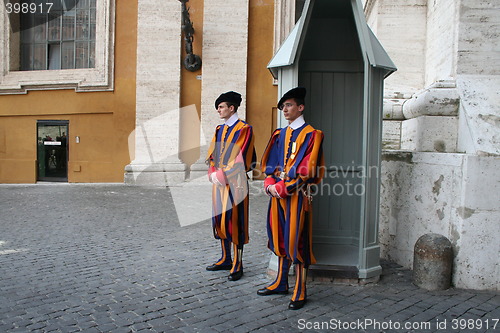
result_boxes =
[257,87,324,310]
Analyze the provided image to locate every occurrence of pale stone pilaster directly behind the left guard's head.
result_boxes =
[190,0,249,179]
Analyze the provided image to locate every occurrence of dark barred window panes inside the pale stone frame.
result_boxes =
[20,0,96,71]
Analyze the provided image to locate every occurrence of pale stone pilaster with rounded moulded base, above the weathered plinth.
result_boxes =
[401,0,460,153]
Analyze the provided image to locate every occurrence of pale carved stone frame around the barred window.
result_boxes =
[0,0,115,94]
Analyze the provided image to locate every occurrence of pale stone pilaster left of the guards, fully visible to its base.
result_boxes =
[125,0,185,185]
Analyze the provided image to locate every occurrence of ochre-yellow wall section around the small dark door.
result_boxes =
[0,0,137,183]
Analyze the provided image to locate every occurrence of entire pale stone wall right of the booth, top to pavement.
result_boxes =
[365,0,500,290]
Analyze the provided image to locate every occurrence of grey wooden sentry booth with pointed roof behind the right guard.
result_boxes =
[268,0,396,279]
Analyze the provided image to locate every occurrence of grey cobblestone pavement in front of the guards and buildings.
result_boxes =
[0,184,500,332]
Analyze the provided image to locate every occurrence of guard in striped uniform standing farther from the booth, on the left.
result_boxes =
[206,91,256,281]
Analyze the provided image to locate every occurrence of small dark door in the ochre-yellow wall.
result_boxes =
[37,120,69,182]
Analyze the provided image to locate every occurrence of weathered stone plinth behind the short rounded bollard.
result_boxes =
[379,151,500,290]
